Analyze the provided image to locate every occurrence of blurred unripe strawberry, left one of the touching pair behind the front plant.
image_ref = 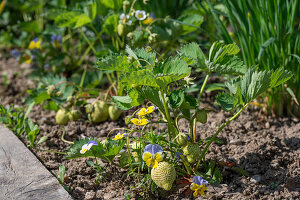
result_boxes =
[91,101,108,123]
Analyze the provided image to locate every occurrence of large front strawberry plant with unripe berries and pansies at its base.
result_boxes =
[67,42,292,196]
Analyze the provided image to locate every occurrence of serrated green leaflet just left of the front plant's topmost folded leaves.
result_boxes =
[178,42,206,68]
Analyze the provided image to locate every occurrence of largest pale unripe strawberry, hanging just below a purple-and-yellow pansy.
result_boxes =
[151,162,176,190]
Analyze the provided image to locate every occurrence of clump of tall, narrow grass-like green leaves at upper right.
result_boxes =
[203,0,300,117]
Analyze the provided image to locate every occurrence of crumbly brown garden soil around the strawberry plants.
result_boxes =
[0,59,300,199]
